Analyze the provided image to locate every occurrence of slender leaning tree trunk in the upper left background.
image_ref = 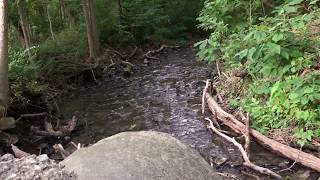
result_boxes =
[16,0,32,48]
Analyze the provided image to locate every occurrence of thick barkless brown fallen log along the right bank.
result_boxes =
[206,93,320,172]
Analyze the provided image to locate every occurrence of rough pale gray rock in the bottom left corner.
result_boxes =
[0,154,76,180]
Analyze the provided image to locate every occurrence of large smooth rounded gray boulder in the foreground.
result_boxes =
[61,131,221,180]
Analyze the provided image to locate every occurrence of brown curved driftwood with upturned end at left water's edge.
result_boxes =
[31,116,77,138]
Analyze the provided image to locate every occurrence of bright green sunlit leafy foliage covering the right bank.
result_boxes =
[196,0,320,144]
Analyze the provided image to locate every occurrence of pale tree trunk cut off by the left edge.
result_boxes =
[0,0,9,118]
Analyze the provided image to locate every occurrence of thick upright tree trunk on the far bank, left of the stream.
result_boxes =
[82,0,100,59]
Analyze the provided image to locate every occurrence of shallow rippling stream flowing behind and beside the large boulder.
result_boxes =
[61,48,315,179]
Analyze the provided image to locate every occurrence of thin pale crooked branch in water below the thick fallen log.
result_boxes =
[206,118,282,179]
